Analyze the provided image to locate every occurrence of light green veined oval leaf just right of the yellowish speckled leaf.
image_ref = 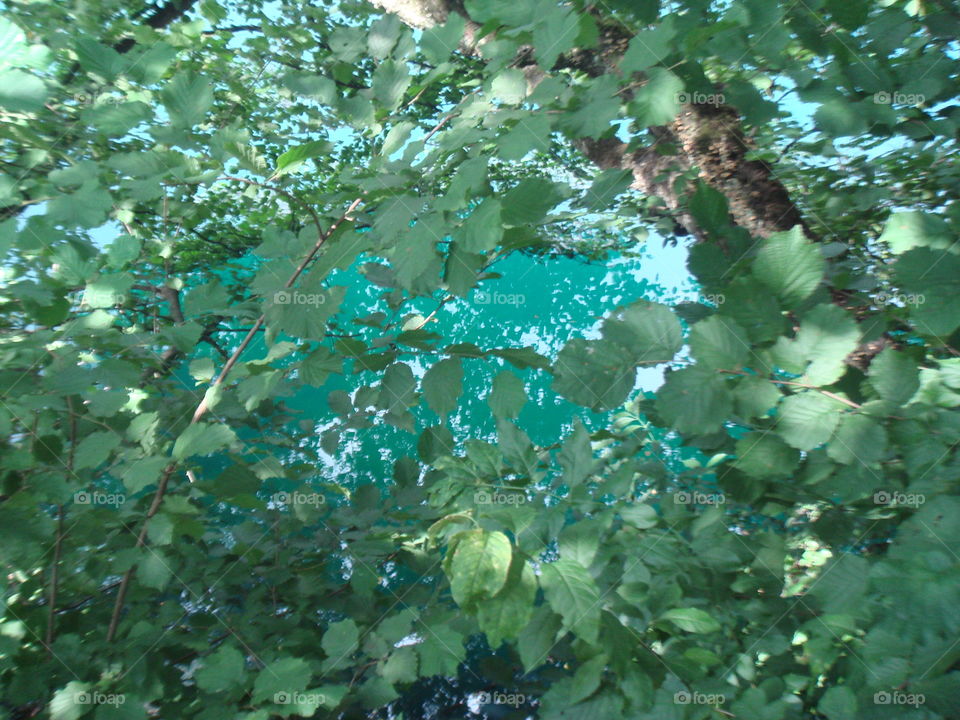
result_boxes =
[540,558,602,643]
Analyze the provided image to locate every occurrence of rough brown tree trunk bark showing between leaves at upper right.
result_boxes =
[370,0,809,240]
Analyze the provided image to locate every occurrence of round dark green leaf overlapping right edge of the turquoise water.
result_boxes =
[553,338,636,412]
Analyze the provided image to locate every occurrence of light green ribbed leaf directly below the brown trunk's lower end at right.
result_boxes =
[753,225,826,309]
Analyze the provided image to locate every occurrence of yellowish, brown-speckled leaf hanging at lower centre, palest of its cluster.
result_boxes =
[450,529,512,607]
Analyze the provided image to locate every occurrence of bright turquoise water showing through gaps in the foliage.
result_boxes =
[255,243,697,487]
